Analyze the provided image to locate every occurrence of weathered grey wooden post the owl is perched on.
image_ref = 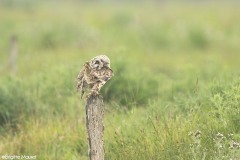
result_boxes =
[86,95,104,160]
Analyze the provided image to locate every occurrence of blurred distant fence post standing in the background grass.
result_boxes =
[9,35,18,73]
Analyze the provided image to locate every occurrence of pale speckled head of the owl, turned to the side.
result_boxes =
[90,55,110,70]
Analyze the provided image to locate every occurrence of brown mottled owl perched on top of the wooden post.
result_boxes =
[77,55,113,99]
